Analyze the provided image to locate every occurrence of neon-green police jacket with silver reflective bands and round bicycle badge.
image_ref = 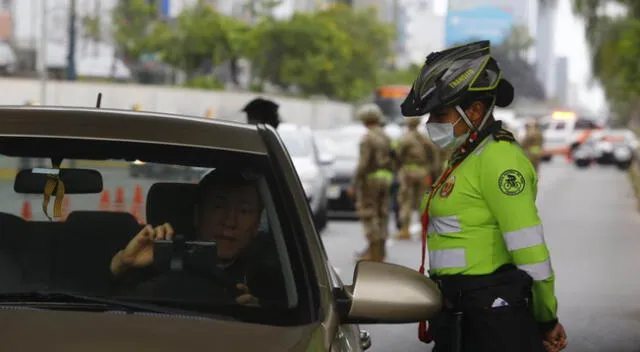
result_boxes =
[422,131,557,323]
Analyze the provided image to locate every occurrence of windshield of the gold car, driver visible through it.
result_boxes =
[0,136,308,325]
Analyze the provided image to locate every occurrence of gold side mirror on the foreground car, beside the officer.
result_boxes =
[343,261,442,324]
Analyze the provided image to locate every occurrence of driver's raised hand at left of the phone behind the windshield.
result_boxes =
[111,223,174,276]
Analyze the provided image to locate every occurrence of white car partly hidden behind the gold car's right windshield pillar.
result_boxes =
[278,124,334,231]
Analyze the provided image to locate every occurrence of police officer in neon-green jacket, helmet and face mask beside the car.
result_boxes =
[402,41,567,352]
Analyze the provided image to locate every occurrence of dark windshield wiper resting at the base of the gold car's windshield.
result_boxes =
[0,291,197,315]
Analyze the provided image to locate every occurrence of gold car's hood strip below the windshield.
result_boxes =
[2,309,322,352]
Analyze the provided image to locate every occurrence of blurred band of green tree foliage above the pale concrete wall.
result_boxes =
[113,0,398,101]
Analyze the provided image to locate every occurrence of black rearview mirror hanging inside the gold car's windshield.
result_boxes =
[13,168,102,195]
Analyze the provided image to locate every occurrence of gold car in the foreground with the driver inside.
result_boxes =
[0,107,442,352]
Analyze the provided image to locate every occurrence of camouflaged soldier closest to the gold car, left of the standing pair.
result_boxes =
[349,104,393,261]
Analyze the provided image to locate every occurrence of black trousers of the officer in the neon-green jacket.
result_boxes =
[429,266,545,352]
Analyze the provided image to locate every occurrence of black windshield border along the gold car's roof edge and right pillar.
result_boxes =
[0,133,317,326]
